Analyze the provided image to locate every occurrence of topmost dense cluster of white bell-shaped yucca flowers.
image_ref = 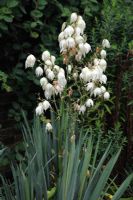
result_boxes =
[58,13,91,63]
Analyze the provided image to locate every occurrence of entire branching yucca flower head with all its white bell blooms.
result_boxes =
[25,13,110,131]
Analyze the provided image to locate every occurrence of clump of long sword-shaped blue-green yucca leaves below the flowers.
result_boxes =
[1,112,133,200]
